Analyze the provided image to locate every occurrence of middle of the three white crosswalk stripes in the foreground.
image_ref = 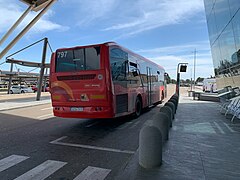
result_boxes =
[15,160,67,180]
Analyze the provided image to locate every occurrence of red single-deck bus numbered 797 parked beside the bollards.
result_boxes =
[50,42,166,118]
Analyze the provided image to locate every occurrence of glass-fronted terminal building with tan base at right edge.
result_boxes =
[204,0,240,89]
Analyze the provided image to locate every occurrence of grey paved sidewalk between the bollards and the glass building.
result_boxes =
[116,93,240,180]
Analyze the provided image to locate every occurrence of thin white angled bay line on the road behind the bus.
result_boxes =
[50,136,135,154]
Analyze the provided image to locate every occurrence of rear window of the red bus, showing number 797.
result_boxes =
[56,46,100,72]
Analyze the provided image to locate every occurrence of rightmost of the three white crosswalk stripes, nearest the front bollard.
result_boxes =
[73,166,111,180]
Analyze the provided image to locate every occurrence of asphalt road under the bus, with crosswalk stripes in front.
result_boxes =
[0,104,158,180]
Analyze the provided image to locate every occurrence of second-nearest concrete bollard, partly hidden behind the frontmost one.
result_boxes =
[152,112,170,142]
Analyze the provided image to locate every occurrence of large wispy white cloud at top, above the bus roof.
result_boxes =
[66,0,205,39]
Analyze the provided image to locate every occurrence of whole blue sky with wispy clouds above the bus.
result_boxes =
[0,0,214,79]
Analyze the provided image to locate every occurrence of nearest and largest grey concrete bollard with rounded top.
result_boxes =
[138,126,163,168]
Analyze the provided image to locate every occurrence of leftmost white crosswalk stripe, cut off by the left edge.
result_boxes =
[0,155,29,172]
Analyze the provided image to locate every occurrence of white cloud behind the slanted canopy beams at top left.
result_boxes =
[0,0,68,33]
